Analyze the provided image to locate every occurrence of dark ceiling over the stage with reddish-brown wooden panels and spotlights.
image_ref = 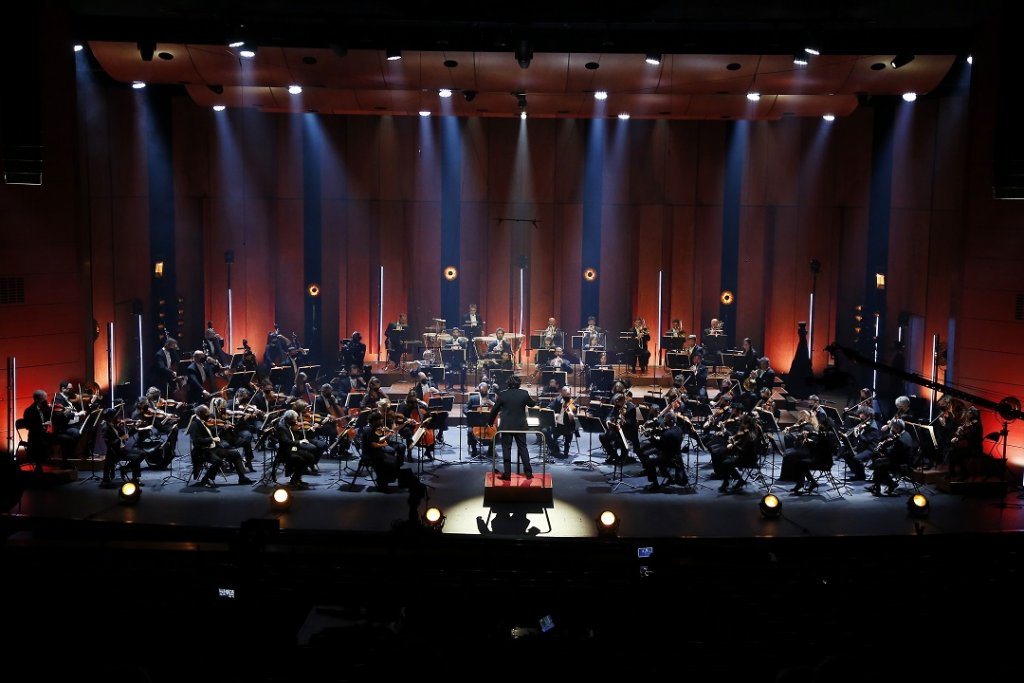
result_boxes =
[71,0,1000,119]
